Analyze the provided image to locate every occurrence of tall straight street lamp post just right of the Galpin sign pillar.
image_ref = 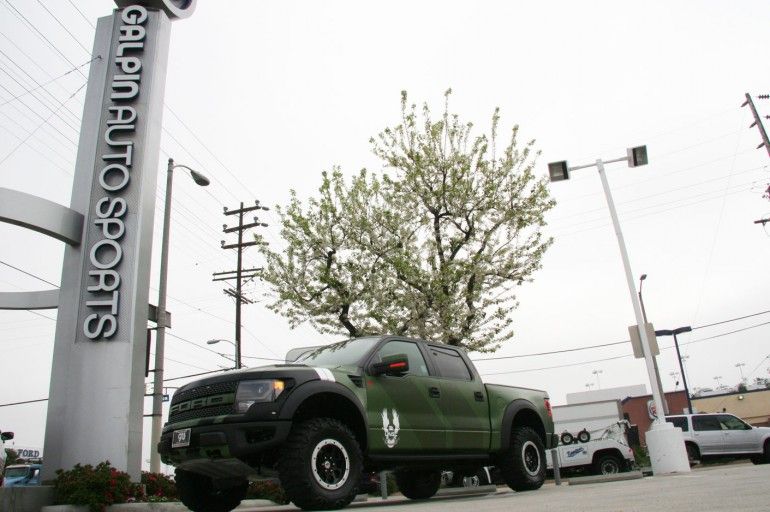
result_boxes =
[150,158,174,473]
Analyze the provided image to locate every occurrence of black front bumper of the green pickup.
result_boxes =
[158,421,291,465]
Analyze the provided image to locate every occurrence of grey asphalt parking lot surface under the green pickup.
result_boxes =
[238,463,770,512]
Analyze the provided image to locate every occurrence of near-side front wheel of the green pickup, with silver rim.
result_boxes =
[278,418,363,510]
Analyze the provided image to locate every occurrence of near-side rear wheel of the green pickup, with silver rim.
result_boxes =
[499,427,545,491]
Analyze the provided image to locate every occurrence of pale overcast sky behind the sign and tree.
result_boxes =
[0,0,770,472]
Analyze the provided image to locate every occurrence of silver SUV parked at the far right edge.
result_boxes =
[666,413,770,464]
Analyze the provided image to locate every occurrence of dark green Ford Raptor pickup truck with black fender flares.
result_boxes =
[158,336,558,512]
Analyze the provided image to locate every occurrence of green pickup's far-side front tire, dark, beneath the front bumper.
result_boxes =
[175,469,249,512]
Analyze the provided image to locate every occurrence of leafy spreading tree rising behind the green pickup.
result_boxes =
[257,91,555,352]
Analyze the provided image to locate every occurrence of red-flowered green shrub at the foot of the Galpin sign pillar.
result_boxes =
[54,461,143,512]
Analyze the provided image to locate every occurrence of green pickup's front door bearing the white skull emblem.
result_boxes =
[366,340,446,454]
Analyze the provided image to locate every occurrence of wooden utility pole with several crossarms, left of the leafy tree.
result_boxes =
[212,201,270,368]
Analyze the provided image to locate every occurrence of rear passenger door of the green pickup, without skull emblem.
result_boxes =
[428,345,491,452]
